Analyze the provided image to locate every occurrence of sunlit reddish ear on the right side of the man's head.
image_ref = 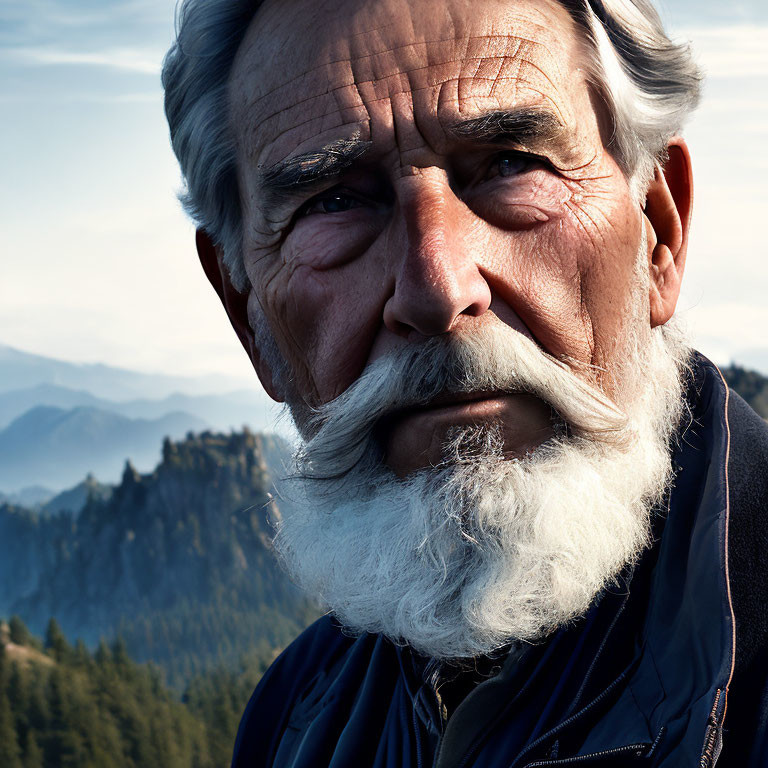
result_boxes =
[645,136,693,328]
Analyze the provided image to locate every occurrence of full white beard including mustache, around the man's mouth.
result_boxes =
[275,322,689,658]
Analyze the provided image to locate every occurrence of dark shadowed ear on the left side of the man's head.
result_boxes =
[195,229,283,402]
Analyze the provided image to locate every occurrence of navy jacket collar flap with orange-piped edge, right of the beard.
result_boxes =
[580,354,735,768]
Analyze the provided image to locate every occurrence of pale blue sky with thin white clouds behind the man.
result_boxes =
[0,0,768,386]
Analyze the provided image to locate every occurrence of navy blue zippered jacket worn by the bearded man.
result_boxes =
[233,357,768,768]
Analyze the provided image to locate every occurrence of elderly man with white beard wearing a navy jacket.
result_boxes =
[163,0,768,768]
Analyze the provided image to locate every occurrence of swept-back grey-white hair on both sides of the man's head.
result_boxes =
[162,0,701,290]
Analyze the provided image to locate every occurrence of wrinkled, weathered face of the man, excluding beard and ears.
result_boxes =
[231,0,648,474]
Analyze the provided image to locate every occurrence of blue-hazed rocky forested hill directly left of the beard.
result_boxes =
[0,431,315,686]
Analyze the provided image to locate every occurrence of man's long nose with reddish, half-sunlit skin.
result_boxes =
[384,177,491,337]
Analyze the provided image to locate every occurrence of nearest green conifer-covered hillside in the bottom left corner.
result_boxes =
[0,619,264,768]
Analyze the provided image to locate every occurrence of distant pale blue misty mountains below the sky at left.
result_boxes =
[0,345,289,496]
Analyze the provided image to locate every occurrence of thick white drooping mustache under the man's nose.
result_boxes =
[297,321,633,479]
